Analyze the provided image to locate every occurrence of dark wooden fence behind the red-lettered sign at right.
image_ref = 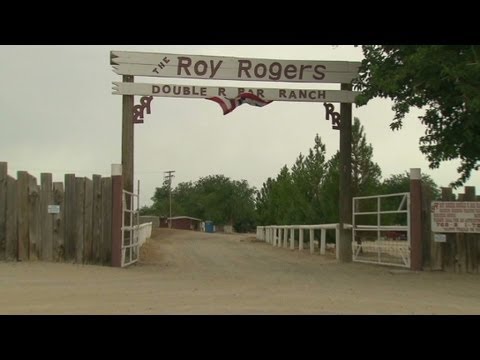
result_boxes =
[422,186,480,273]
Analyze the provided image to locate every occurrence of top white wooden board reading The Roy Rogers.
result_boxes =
[110,51,360,83]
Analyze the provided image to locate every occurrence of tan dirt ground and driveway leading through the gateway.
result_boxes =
[0,229,480,314]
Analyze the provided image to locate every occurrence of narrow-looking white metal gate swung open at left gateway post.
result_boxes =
[122,182,140,267]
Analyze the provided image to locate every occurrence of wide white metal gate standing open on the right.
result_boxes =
[352,193,410,268]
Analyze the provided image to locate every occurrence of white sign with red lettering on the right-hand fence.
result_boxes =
[431,201,480,233]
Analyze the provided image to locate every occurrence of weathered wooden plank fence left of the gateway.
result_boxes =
[0,162,112,265]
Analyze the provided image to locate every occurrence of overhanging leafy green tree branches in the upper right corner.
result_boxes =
[354,45,480,187]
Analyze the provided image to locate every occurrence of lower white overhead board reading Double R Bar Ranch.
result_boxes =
[113,82,358,103]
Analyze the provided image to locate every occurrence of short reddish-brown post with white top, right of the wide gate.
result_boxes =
[410,169,422,271]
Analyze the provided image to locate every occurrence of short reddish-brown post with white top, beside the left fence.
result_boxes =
[112,164,123,267]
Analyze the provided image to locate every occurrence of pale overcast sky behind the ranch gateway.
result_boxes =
[0,45,480,205]
